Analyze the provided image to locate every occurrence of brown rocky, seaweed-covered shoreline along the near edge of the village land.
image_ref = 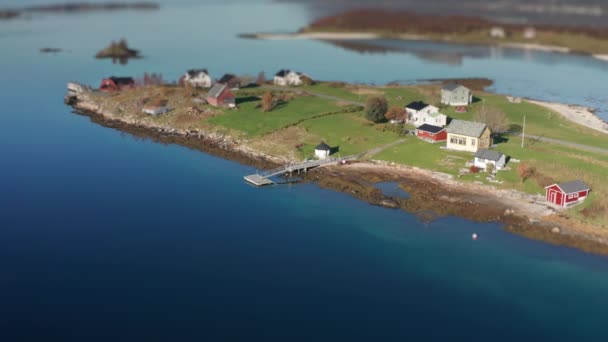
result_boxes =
[70,94,608,255]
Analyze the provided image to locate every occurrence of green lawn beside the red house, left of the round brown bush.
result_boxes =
[208,96,345,136]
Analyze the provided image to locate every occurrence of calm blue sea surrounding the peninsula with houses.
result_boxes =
[0,1,608,342]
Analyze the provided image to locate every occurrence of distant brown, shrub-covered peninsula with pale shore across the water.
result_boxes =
[242,9,608,59]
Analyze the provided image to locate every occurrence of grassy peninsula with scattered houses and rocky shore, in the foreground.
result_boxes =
[66,74,608,254]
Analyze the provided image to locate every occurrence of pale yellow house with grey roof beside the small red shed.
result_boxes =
[447,120,492,152]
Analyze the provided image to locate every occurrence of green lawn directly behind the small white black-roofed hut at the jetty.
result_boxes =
[298,113,399,156]
